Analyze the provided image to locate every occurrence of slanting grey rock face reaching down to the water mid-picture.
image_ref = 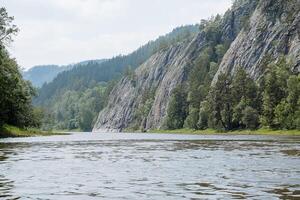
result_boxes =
[93,35,206,132]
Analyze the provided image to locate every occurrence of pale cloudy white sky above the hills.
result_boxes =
[0,0,232,69]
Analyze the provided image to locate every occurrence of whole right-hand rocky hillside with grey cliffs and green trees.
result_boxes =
[94,0,300,131]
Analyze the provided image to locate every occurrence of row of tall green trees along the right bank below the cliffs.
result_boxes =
[166,57,300,131]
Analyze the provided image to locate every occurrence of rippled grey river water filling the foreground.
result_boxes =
[0,133,300,200]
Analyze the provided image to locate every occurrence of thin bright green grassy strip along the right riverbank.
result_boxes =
[148,129,300,136]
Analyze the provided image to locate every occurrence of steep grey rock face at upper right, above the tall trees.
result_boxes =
[213,0,300,82]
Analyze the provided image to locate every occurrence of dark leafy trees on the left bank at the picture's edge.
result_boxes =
[0,8,41,134]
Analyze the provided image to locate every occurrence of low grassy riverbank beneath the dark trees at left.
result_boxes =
[0,125,66,138]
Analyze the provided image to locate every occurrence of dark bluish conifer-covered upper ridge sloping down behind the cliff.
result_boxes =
[35,25,198,105]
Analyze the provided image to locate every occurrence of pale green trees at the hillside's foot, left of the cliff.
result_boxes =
[42,83,114,131]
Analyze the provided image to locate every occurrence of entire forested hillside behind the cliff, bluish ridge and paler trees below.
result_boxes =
[34,25,199,130]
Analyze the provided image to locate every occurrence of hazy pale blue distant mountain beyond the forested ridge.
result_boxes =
[22,60,104,87]
